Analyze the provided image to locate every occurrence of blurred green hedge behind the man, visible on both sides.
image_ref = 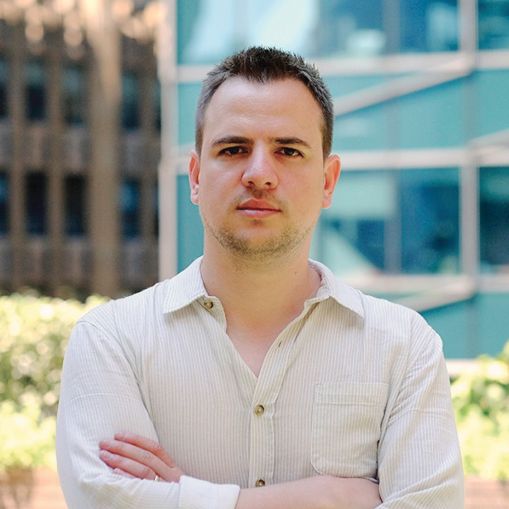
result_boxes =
[0,294,509,479]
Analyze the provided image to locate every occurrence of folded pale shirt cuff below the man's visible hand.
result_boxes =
[178,475,240,509]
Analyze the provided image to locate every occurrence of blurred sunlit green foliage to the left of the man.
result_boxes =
[0,294,103,470]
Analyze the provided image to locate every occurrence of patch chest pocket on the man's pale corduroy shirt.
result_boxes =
[311,382,388,477]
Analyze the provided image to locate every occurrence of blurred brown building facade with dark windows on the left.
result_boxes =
[0,1,160,295]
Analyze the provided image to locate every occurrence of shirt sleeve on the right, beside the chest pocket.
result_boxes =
[378,315,464,509]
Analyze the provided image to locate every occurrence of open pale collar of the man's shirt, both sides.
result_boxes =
[163,257,364,318]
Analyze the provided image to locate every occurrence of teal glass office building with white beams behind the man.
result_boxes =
[160,0,509,358]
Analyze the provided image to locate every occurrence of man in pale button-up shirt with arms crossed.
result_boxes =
[57,48,463,509]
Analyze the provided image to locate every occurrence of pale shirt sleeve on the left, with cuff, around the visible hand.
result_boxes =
[57,321,240,509]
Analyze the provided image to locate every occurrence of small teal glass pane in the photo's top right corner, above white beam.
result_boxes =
[478,0,509,49]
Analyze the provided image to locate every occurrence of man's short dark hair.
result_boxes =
[195,46,334,157]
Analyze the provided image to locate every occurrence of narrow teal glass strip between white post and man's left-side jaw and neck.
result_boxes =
[177,175,203,270]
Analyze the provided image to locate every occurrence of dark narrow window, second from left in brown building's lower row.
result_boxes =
[25,172,48,235]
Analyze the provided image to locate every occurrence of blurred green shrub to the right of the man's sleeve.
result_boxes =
[452,342,509,480]
